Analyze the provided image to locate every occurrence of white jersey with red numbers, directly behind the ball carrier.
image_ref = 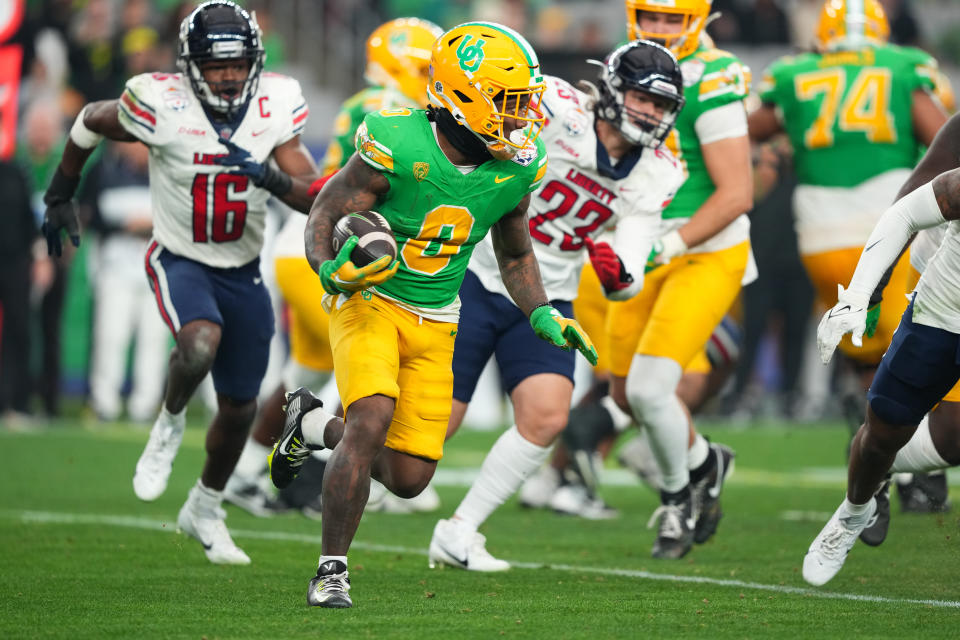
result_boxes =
[470,76,684,300]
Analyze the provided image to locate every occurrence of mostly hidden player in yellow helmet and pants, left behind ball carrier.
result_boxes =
[225,18,443,515]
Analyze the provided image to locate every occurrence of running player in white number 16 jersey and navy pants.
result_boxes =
[44,0,319,564]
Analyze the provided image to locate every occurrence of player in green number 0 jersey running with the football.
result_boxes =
[271,22,597,608]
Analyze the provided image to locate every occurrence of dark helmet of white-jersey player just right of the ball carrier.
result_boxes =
[591,40,684,149]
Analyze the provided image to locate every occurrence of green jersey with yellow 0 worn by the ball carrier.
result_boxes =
[356,108,547,309]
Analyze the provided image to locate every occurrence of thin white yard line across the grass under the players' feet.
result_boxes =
[7,510,960,609]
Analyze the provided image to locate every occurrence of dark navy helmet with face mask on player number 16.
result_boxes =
[177,0,264,119]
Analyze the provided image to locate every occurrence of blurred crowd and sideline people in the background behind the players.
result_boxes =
[0,0,960,425]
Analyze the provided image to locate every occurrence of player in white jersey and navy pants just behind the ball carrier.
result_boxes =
[429,40,684,571]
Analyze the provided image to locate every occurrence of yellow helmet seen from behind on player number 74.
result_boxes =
[817,0,890,51]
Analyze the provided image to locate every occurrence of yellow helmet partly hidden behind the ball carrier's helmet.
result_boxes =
[364,18,443,107]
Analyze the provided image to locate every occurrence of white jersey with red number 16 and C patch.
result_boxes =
[119,73,308,267]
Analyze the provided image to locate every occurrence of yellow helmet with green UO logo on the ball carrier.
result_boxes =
[427,22,546,159]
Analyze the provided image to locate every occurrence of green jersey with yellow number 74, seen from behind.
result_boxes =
[759,45,937,187]
